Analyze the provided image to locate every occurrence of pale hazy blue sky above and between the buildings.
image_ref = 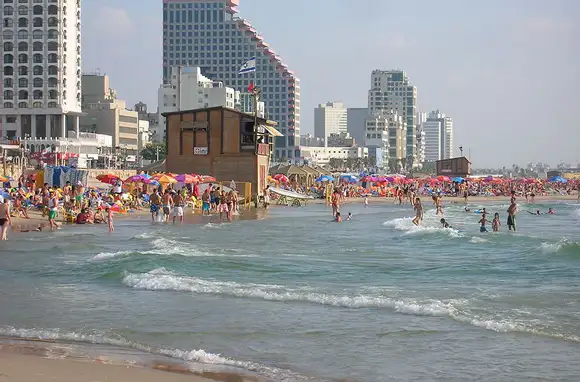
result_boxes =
[82,0,580,168]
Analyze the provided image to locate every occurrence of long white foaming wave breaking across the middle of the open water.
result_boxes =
[123,268,580,342]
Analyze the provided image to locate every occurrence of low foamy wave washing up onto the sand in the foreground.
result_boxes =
[0,326,308,382]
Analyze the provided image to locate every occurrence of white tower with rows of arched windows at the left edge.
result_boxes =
[0,0,82,138]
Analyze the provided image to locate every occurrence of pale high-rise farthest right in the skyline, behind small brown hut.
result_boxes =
[422,110,453,162]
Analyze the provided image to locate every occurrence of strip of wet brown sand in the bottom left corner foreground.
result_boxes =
[0,337,267,382]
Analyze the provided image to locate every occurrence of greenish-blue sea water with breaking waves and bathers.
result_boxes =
[0,202,580,381]
